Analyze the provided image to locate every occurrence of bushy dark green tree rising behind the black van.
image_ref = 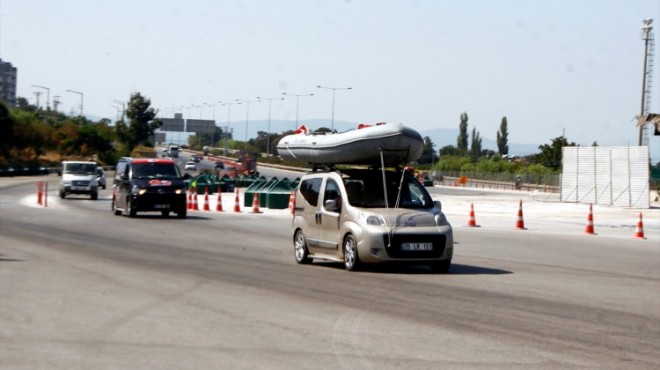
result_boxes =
[123,92,162,152]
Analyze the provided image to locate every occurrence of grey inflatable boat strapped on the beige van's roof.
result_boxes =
[277,123,424,165]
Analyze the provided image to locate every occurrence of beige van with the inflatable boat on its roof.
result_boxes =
[292,168,454,273]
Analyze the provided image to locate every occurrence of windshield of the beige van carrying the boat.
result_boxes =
[342,170,434,209]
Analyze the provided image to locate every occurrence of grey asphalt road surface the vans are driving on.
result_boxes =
[0,176,660,369]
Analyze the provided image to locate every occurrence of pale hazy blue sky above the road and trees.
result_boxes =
[0,0,660,158]
